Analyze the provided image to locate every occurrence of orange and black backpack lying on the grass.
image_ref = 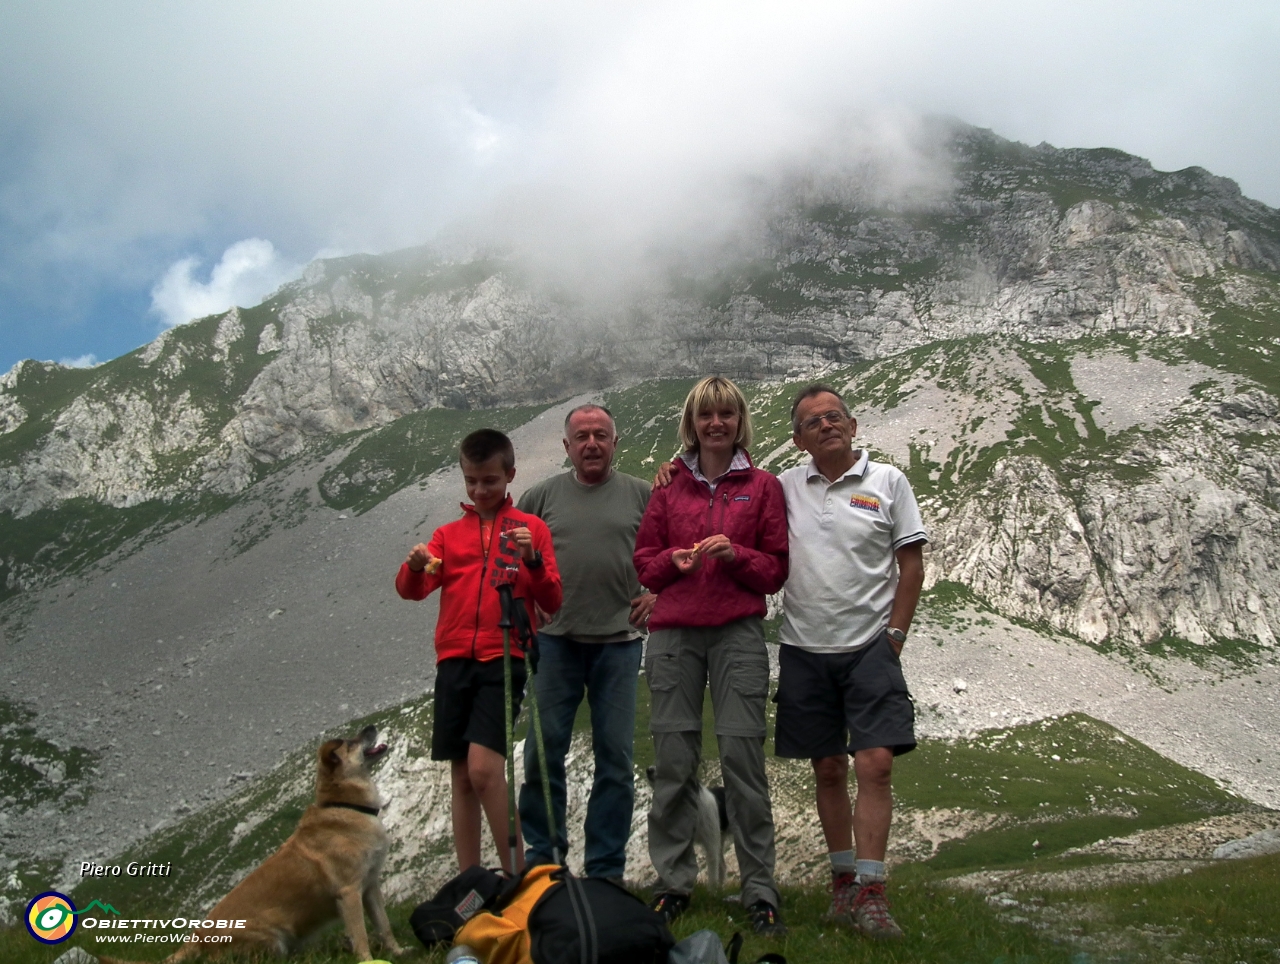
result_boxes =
[453,864,676,964]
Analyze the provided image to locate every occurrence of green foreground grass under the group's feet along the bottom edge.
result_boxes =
[10,855,1280,964]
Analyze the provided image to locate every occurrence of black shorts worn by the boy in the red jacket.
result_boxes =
[431,657,525,760]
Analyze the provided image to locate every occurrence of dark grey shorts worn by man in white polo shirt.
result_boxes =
[773,632,915,759]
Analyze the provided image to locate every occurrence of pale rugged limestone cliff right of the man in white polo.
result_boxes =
[929,442,1280,648]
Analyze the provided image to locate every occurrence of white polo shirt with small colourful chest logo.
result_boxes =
[778,449,929,653]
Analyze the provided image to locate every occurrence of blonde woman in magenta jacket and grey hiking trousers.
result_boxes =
[635,376,787,936]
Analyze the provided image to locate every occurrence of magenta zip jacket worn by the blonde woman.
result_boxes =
[635,453,787,630]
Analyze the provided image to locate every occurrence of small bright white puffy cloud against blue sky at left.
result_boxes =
[151,238,301,328]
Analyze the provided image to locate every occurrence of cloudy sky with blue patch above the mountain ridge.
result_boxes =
[0,0,1280,371]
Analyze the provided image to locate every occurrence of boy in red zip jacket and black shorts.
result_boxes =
[396,429,561,873]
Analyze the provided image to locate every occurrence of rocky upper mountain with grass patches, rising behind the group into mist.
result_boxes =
[0,127,1280,645]
